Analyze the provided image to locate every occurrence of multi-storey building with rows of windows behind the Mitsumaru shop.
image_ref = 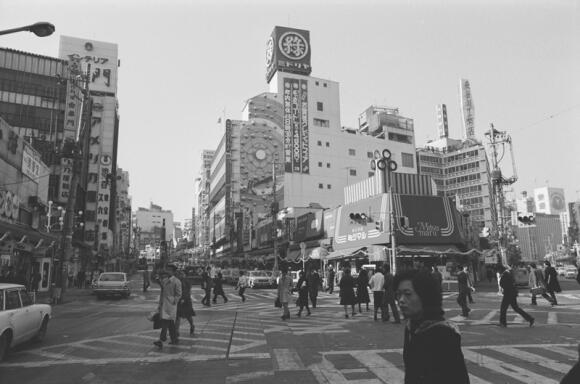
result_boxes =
[417,138,496,229]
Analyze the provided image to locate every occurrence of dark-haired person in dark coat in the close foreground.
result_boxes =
[394,270,469,384]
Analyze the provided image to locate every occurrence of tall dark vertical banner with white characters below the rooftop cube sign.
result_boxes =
[283,78,310,174]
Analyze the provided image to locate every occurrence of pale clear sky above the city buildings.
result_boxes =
[0,0,580,221]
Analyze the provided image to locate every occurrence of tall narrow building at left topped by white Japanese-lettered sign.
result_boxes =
[59,36,119,269]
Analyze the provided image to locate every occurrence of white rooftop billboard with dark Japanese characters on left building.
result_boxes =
[58,36,119,94]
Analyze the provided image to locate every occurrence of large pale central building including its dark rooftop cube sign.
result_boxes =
[204,27,426,257]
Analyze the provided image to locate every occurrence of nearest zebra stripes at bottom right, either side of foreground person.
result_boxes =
[314,344,578,384]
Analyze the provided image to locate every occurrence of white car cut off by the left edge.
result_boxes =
[0,284,52,361]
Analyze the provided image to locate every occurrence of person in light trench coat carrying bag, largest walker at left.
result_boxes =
[153,265,181,348]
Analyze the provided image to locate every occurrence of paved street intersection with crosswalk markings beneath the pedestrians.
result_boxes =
[0,281,580,384]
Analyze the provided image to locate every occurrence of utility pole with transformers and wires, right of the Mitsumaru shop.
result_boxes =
[485,124,518,262]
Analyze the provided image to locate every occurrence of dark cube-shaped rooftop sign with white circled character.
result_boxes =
[266,26,312,82]
